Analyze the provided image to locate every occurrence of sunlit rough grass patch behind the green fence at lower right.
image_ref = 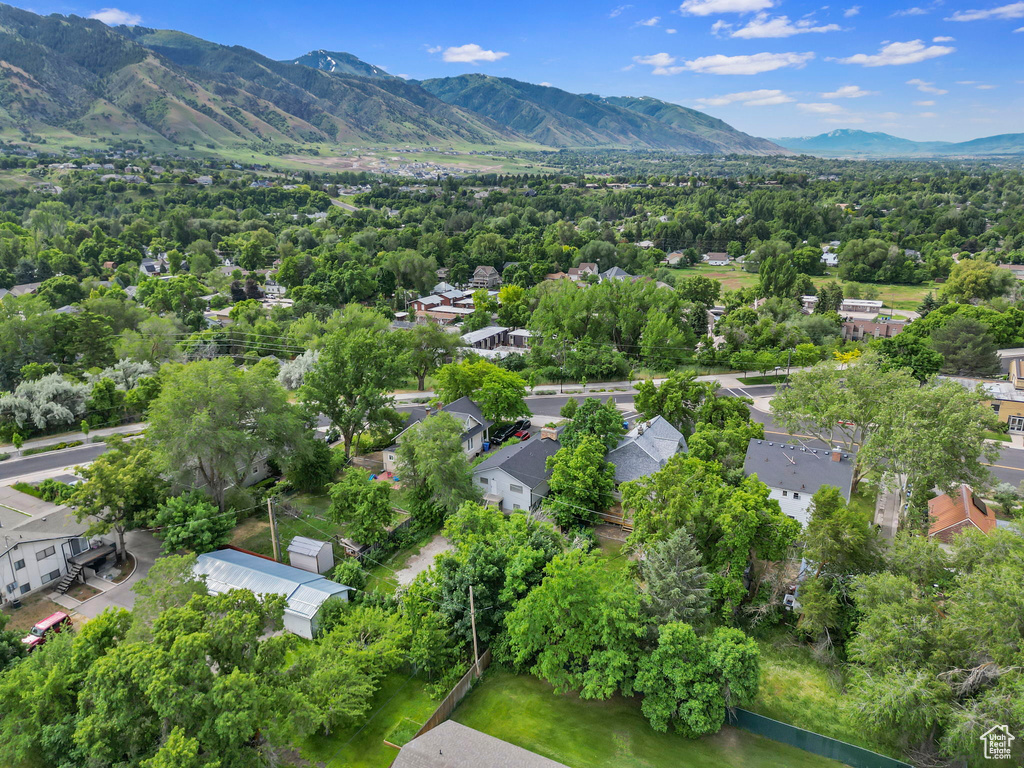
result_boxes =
[749,635,898,758]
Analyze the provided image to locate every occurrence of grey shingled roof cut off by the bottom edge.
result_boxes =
[391,720,566,768]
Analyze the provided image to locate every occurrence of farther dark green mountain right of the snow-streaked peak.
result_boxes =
[421,74,786,155]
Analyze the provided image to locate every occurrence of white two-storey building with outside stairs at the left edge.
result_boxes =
[0,478,115,602]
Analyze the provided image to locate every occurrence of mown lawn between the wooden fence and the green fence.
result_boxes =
[454,667,840,768]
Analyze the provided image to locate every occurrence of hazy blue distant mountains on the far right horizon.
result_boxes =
[775,128,1024,158]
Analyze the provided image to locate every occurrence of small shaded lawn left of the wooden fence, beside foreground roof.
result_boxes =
[297,673,439,768]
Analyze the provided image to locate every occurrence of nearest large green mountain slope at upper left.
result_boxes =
[0,4,523,150]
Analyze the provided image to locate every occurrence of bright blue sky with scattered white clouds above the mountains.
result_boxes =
[14,0,1024,140]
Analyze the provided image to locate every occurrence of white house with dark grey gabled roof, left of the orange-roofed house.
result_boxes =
[743,439,856,525]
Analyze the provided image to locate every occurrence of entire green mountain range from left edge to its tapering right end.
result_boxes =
[0,4,790,155]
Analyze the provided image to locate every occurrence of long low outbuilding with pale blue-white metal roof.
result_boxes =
[193,549,351,639]
